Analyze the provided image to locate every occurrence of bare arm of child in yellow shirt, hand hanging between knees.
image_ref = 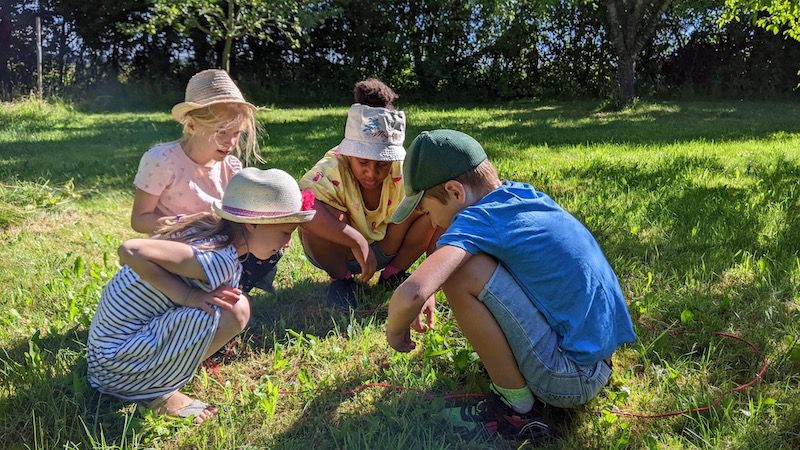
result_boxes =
[301,200,378,281]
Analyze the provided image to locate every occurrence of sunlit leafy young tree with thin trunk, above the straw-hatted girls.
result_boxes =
[136,0,326,72]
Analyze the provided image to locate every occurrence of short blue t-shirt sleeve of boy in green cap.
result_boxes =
[437,208,499,255]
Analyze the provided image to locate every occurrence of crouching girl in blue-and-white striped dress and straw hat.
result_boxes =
[86,168,314,423]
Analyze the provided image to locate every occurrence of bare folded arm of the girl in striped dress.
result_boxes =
[118,239,241,315]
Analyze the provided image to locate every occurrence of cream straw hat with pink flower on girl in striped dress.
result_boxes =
[214,167,316,224]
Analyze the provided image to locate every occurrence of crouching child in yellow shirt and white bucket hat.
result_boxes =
[300,79,434,308]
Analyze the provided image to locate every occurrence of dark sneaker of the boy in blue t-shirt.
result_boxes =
[442,392,554,445]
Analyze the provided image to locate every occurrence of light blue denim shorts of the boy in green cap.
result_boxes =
[478,264,611,408]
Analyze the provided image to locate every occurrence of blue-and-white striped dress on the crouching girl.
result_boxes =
[86,245,242,401]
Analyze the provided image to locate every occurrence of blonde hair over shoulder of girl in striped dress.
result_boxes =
[153,212,247,250]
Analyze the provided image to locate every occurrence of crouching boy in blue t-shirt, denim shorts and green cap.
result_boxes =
[386,130,636,435]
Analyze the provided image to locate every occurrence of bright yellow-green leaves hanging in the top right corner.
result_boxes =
[720,0,800,41]
